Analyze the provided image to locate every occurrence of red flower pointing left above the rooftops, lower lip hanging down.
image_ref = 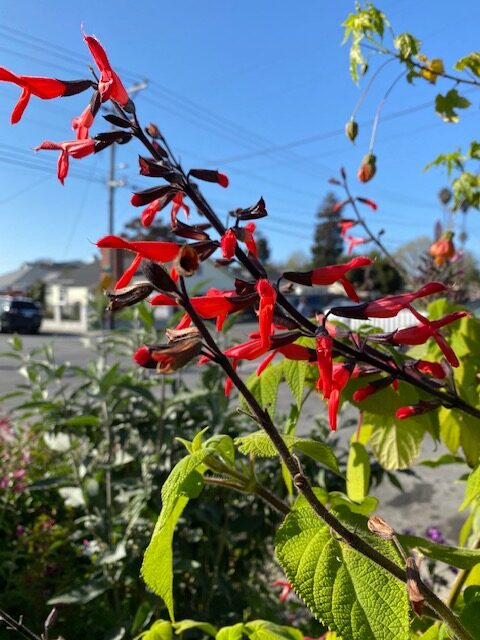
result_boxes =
[97,236,180,289]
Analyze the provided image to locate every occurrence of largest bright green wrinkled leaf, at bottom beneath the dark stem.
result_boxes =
[276,508,409,640]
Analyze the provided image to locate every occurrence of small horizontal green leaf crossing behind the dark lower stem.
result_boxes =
[235,431,338,472]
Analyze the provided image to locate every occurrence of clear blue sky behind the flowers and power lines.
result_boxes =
[0,0,480,273]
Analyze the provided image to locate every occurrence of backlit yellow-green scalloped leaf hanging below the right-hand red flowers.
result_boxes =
[370,414,425,471]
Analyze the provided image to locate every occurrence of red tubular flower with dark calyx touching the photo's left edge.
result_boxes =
[0,67,92,124]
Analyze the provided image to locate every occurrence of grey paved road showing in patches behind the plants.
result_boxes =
[0,325,464,543]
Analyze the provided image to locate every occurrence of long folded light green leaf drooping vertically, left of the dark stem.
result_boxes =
[141,448,214,620]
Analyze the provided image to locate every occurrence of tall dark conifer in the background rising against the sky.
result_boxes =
[312,193,343,267]
